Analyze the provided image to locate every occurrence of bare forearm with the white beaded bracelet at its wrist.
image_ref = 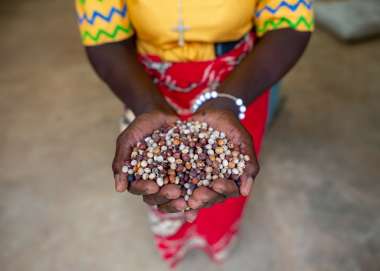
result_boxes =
[206,29,310,114]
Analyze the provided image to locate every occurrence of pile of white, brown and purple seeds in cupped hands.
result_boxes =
[122,121,249,200]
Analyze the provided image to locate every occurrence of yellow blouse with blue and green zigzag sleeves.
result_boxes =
[76,0,314,61]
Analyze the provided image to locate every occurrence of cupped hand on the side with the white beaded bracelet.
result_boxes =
[188,109,259,209]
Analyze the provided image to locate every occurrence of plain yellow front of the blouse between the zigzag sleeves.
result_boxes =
[127,0,256,61]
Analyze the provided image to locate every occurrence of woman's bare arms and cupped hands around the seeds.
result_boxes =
[86,29,311,220]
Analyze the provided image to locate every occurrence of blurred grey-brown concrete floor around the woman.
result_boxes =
[0,0,380,271]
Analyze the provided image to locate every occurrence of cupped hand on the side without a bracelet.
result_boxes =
[112,111,186,212]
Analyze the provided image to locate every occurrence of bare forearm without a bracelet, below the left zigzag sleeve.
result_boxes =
[86,39,171,115]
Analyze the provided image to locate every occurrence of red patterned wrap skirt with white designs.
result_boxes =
[140,34,268,267]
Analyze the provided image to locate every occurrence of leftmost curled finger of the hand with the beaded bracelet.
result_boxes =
[188,186,224,209]
